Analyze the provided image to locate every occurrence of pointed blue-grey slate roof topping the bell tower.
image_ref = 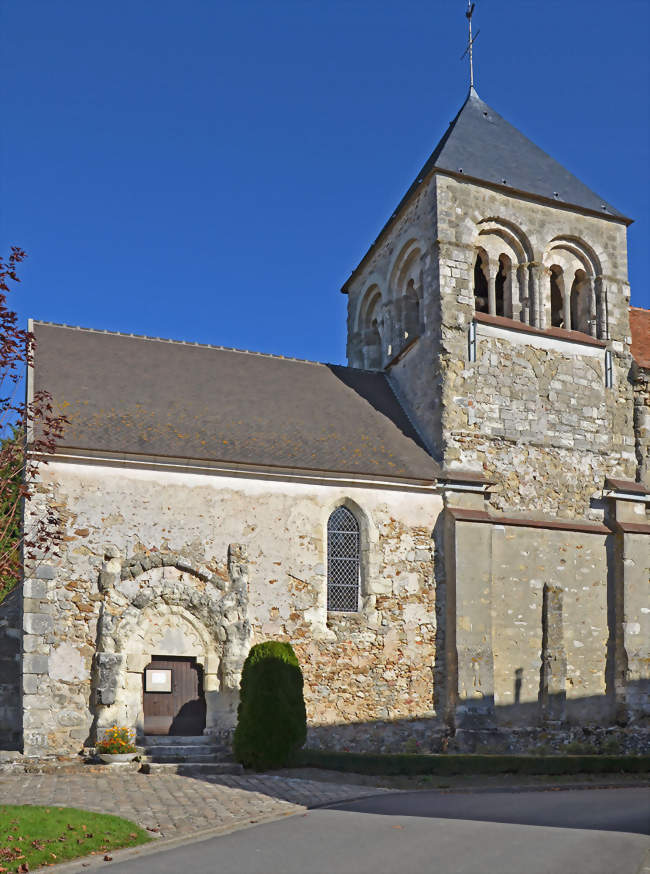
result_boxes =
[405,87,629,221]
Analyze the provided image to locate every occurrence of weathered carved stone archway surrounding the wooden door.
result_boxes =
[93,544,251,735]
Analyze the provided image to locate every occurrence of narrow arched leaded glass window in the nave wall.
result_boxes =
[327,507,361,613]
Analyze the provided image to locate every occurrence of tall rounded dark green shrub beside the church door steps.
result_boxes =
[233,641,307,771]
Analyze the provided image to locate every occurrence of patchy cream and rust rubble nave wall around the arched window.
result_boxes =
[23,463,442,755]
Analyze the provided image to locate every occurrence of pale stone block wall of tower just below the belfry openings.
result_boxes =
[444,325,636,519]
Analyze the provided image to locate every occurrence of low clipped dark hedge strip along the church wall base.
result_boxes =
[290,749,650,776]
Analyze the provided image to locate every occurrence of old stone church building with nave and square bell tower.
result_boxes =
[0,88,650,756]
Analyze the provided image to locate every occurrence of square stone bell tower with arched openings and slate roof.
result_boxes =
[343,87,636,516]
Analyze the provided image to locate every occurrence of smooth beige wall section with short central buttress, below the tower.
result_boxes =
[448,520,613,727]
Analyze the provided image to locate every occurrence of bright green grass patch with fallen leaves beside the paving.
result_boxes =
[0,804,151,872]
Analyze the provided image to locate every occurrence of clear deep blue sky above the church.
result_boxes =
[0,0,650,362]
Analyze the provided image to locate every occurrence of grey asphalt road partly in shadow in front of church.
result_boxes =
[111,788,650,874]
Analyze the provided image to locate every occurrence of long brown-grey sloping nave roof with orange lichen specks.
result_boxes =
[33,322,438,481]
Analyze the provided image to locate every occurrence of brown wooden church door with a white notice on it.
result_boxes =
[143,656,205,736]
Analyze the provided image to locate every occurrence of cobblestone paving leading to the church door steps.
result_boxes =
[0,771,389,838]
